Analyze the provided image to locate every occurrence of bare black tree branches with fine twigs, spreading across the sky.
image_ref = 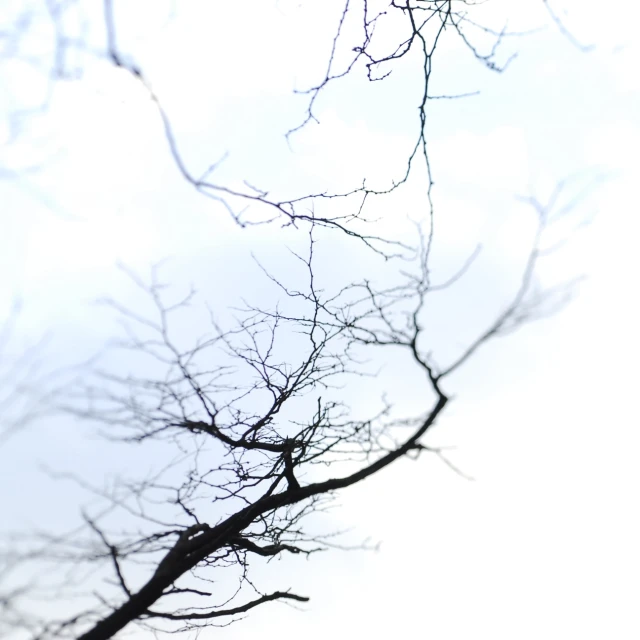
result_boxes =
[3,0,596,640]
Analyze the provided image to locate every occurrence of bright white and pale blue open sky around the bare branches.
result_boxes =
[0,0,640,640]
